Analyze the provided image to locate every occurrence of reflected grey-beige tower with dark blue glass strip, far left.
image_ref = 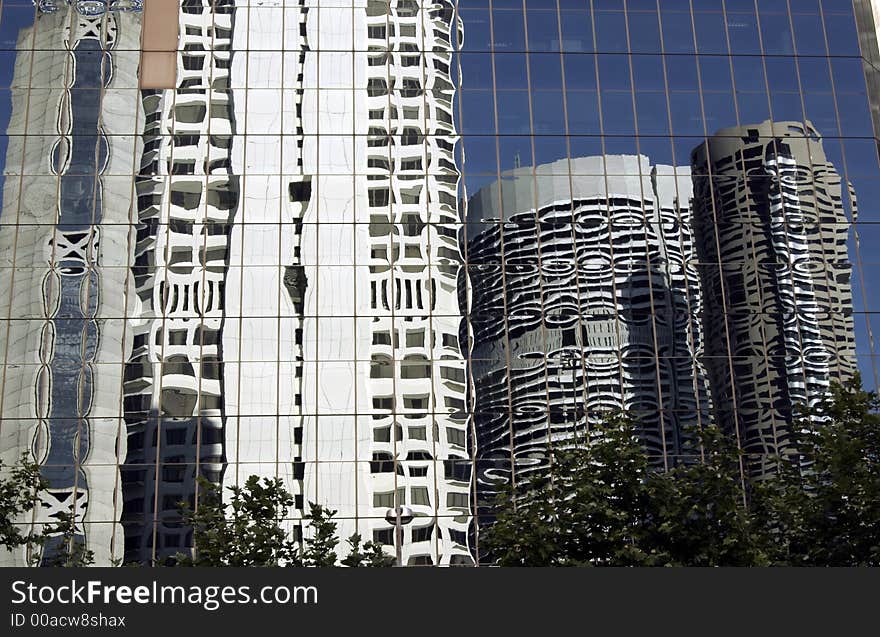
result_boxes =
[0,3,142,564]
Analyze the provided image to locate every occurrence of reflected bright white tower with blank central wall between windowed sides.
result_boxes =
[123,2,469,564]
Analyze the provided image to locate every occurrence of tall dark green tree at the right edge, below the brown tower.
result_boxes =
[753,376,880,566]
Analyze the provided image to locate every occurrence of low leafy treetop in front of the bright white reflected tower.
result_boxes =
[174,475,393,567]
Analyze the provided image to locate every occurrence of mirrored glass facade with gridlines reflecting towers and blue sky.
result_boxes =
[0,0,880,566]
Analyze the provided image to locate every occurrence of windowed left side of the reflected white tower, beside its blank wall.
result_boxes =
[121,2,239,561]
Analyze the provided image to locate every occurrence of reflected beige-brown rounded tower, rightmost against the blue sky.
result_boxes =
[693,121,856,473]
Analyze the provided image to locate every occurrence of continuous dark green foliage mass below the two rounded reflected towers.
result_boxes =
[482,386,880,566]
